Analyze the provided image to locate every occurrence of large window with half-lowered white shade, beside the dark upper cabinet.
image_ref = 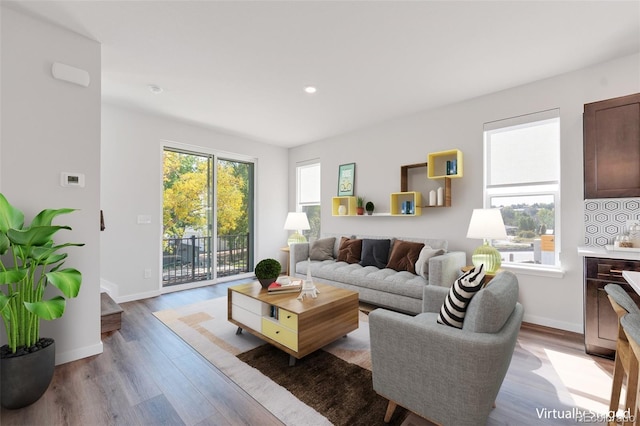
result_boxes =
[484,109,560,267]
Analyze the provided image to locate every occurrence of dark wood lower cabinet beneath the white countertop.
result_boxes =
[584,257,640,359]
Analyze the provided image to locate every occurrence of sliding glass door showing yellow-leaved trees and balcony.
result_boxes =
[162,148,253,286]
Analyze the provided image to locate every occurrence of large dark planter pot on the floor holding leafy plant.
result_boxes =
[0,339,56,409]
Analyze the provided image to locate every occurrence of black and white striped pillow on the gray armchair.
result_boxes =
[437,264,485,328]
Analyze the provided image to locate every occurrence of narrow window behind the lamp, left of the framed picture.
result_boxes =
[296,161,320,241]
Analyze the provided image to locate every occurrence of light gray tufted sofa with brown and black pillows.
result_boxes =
[289,234,466,314]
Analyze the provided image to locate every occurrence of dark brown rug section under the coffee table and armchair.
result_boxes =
[238,345,408,426]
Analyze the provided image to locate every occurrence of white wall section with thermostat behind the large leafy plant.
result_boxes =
[0,6,102,364]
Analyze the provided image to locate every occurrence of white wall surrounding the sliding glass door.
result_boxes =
[100,105,288,301]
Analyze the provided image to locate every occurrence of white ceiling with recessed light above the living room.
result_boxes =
[3,0,640,147]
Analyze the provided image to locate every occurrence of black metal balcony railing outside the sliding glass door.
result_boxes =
[162,233,250,286]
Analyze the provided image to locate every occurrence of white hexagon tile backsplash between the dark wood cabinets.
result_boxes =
[584,198,640,246]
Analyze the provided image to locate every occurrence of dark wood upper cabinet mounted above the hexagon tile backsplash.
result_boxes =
[583,93,640,198]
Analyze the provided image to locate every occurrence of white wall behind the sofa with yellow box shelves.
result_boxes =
[289,55,640,332]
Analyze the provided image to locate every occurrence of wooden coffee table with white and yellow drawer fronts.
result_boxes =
[227,281,358,365]
